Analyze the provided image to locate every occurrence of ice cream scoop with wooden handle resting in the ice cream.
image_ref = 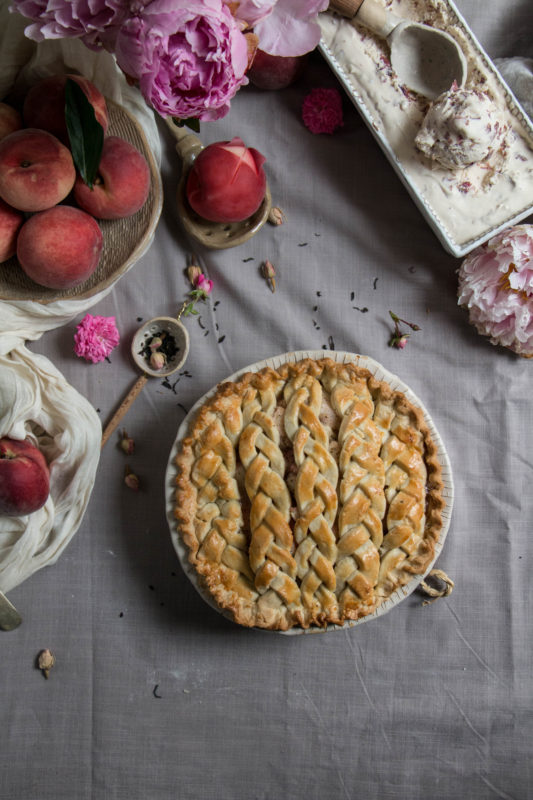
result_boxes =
[329,0,467,100]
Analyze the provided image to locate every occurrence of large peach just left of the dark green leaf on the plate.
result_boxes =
[0,128,76,211]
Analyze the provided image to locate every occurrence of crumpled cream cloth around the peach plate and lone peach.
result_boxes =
[0,3,160,592]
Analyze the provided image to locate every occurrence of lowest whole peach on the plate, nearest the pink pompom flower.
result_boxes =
[17,206,103,289]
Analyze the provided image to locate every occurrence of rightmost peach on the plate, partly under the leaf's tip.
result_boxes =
[74,136,150,219]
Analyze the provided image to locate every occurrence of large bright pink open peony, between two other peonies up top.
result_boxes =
[115,0,248,120]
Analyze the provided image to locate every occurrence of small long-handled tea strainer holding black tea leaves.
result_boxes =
[102,301,189,447]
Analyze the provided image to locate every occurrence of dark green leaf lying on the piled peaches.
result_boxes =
[65,78,104,189]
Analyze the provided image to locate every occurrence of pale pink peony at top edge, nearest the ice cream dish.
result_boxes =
[235,0,329,56]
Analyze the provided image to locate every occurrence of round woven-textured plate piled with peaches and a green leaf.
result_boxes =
[0,75,162,303]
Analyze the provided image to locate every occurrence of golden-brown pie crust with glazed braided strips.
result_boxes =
[174,358,444,630]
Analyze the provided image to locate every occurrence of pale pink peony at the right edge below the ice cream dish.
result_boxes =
[458,225,533,356]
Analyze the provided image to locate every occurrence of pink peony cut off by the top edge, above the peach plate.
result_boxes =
[10,0,129,47]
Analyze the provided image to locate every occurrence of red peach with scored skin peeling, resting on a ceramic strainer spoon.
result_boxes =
[186,137,266,222]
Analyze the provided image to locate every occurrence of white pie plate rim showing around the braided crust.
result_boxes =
[165,350,454,636]
